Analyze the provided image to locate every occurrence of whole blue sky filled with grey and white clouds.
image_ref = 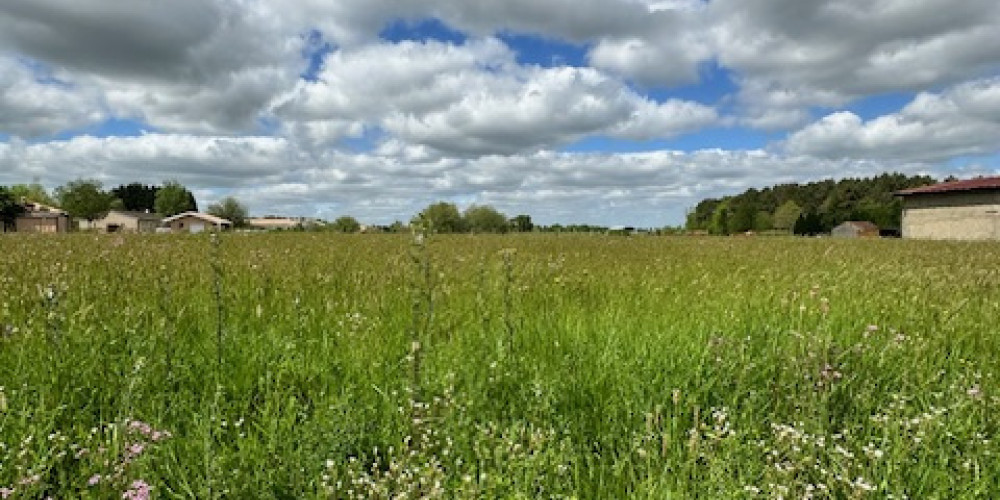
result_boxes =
[0,0,1000,227]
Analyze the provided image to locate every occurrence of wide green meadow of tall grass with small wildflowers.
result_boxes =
[0,233,1000,498]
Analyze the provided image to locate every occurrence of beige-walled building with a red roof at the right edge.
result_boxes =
[896,177,1000,240]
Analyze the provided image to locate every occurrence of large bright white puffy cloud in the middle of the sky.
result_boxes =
[276,38,718,156]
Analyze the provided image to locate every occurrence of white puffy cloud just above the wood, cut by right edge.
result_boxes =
[785,78,1000,161]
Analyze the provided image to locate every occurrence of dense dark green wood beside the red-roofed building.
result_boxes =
[685,173,936,235]
